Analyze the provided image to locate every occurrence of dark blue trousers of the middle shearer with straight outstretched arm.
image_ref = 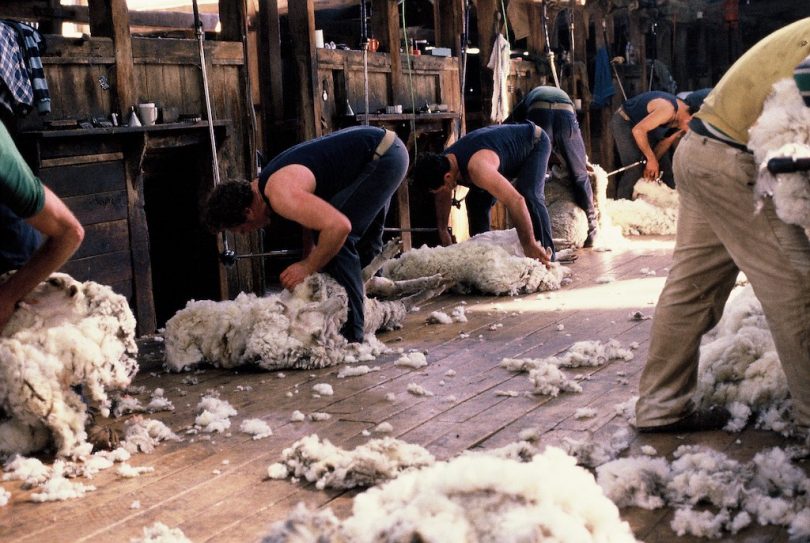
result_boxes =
[466,127,554,252]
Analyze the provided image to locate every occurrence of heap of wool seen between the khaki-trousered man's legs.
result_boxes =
[697,285,793,435]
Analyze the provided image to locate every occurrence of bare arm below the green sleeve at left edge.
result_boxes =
[0,187,84,328]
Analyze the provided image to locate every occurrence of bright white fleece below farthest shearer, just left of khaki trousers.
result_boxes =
[606,179,678,236]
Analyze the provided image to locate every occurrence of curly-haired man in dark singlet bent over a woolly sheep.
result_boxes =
[203,126,408,342]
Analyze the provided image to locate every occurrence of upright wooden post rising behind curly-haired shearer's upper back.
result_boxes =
[287,0,322,141]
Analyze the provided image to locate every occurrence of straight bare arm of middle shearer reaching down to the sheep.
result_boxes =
[467,149,551,264]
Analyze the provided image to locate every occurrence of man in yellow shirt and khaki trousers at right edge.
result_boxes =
[636,18,810,432]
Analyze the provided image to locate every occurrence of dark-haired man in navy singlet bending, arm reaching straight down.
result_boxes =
[413,122,556,264]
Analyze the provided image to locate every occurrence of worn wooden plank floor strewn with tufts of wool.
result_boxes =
[0,240,788,543]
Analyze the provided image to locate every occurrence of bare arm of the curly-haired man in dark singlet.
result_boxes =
[265,165,352,289]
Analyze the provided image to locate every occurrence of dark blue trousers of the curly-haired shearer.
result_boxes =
[323,134,409,341]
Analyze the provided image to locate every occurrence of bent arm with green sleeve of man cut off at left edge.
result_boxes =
[0,123,84,329]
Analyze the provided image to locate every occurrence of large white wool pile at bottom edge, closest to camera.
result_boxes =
[263,447,636,543]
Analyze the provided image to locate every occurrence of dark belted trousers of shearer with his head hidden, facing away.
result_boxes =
[526,109,596,234]
